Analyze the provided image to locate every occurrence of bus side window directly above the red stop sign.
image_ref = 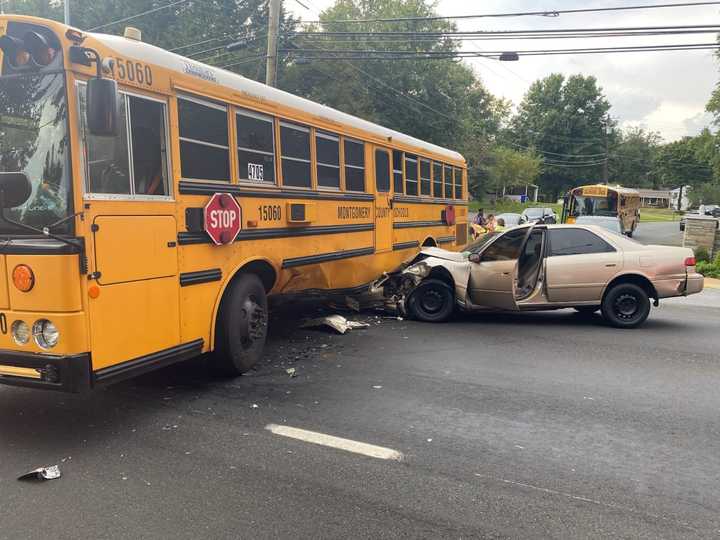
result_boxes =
[178,98,230,182]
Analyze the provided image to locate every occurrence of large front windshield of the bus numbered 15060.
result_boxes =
[0,73,72,234]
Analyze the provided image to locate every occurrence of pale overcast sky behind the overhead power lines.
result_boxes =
[284,0,720,141]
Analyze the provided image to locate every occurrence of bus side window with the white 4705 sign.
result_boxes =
[235,111,275,184]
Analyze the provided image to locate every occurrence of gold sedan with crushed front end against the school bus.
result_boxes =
[373,225,703,328]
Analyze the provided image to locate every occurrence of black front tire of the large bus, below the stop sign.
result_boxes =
[212,274,268,377]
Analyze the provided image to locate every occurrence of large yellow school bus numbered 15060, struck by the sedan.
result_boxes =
[0,15,467,392]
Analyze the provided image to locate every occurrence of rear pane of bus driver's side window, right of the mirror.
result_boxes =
[128,96,168,196]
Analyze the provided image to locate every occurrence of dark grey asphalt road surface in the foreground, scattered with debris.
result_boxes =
[0,291,720,539]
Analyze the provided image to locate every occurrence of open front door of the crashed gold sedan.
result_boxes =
[468,226,544,311]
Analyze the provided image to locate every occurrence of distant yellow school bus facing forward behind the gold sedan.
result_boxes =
[561,184,640,238]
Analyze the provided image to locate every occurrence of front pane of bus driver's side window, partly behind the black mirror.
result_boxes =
[78,85,130,195]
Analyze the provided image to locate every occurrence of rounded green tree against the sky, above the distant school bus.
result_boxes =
[503,73,616,199]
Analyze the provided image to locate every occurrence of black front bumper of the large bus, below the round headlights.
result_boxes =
[0,350,91,393]
